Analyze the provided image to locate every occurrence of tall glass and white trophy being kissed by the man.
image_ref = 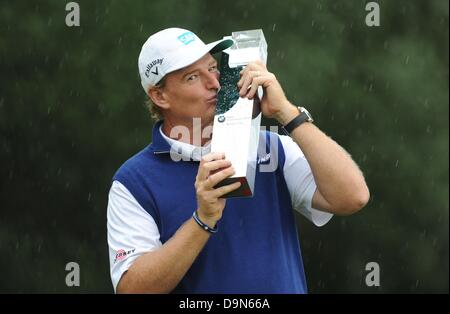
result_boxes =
[211,29,267,198]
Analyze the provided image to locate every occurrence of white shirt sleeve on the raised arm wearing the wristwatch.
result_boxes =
[279,135,333,227]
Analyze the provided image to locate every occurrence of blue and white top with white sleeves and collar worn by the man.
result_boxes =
[107,121,332,293]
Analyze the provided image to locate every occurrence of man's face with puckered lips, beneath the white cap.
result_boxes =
[165,53,220,125]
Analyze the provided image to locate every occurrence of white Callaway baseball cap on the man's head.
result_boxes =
[138,28,233,93]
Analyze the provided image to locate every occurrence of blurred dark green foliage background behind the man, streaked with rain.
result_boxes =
[0,0,449,293]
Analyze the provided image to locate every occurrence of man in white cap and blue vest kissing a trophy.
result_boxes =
[108,28,369,293]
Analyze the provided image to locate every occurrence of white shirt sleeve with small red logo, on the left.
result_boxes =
[107,181,162,292]
